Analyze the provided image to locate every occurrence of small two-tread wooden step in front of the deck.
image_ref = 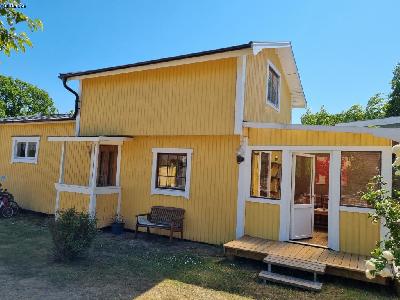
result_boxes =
[259,254,326,291]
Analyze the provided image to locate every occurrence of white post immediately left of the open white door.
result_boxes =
[279,149,293,241]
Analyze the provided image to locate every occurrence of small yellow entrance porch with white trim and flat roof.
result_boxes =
[48,136,132,228]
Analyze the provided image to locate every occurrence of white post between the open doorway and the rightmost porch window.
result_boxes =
[328,151,341,251]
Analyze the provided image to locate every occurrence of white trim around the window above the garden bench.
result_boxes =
[151,148,193,199]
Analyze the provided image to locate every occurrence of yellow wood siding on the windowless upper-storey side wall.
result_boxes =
[80,58,236,136]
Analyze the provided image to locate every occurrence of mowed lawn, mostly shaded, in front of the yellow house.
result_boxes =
[0,214,397,299]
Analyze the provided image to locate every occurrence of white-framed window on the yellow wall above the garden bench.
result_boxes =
[151,148,193,199]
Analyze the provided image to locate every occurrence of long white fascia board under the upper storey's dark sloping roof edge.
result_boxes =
[67,49,251,81]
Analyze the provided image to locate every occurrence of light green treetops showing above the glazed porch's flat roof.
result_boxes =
[301,94,387,126]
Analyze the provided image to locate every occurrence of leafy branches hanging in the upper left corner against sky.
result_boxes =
[0,0,43,56]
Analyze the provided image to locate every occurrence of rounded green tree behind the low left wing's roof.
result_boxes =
[0,75,57,117]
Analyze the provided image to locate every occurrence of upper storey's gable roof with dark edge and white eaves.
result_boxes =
[58,41,307,108]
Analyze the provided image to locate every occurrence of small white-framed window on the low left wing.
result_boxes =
[11,136,40,164]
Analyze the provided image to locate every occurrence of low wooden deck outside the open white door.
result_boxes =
[224,235,388,284]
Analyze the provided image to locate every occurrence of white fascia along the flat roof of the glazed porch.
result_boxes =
[243,122,400,141]
